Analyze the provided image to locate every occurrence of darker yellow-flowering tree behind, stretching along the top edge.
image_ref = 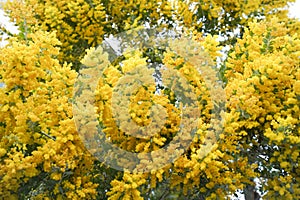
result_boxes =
[4,0,294,70]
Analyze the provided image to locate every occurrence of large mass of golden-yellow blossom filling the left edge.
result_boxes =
[0,31,97,199]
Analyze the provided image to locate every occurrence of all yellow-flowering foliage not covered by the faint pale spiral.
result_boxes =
[0,0,300,200]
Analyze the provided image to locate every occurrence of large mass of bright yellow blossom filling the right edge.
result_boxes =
[226,18,300,199]
